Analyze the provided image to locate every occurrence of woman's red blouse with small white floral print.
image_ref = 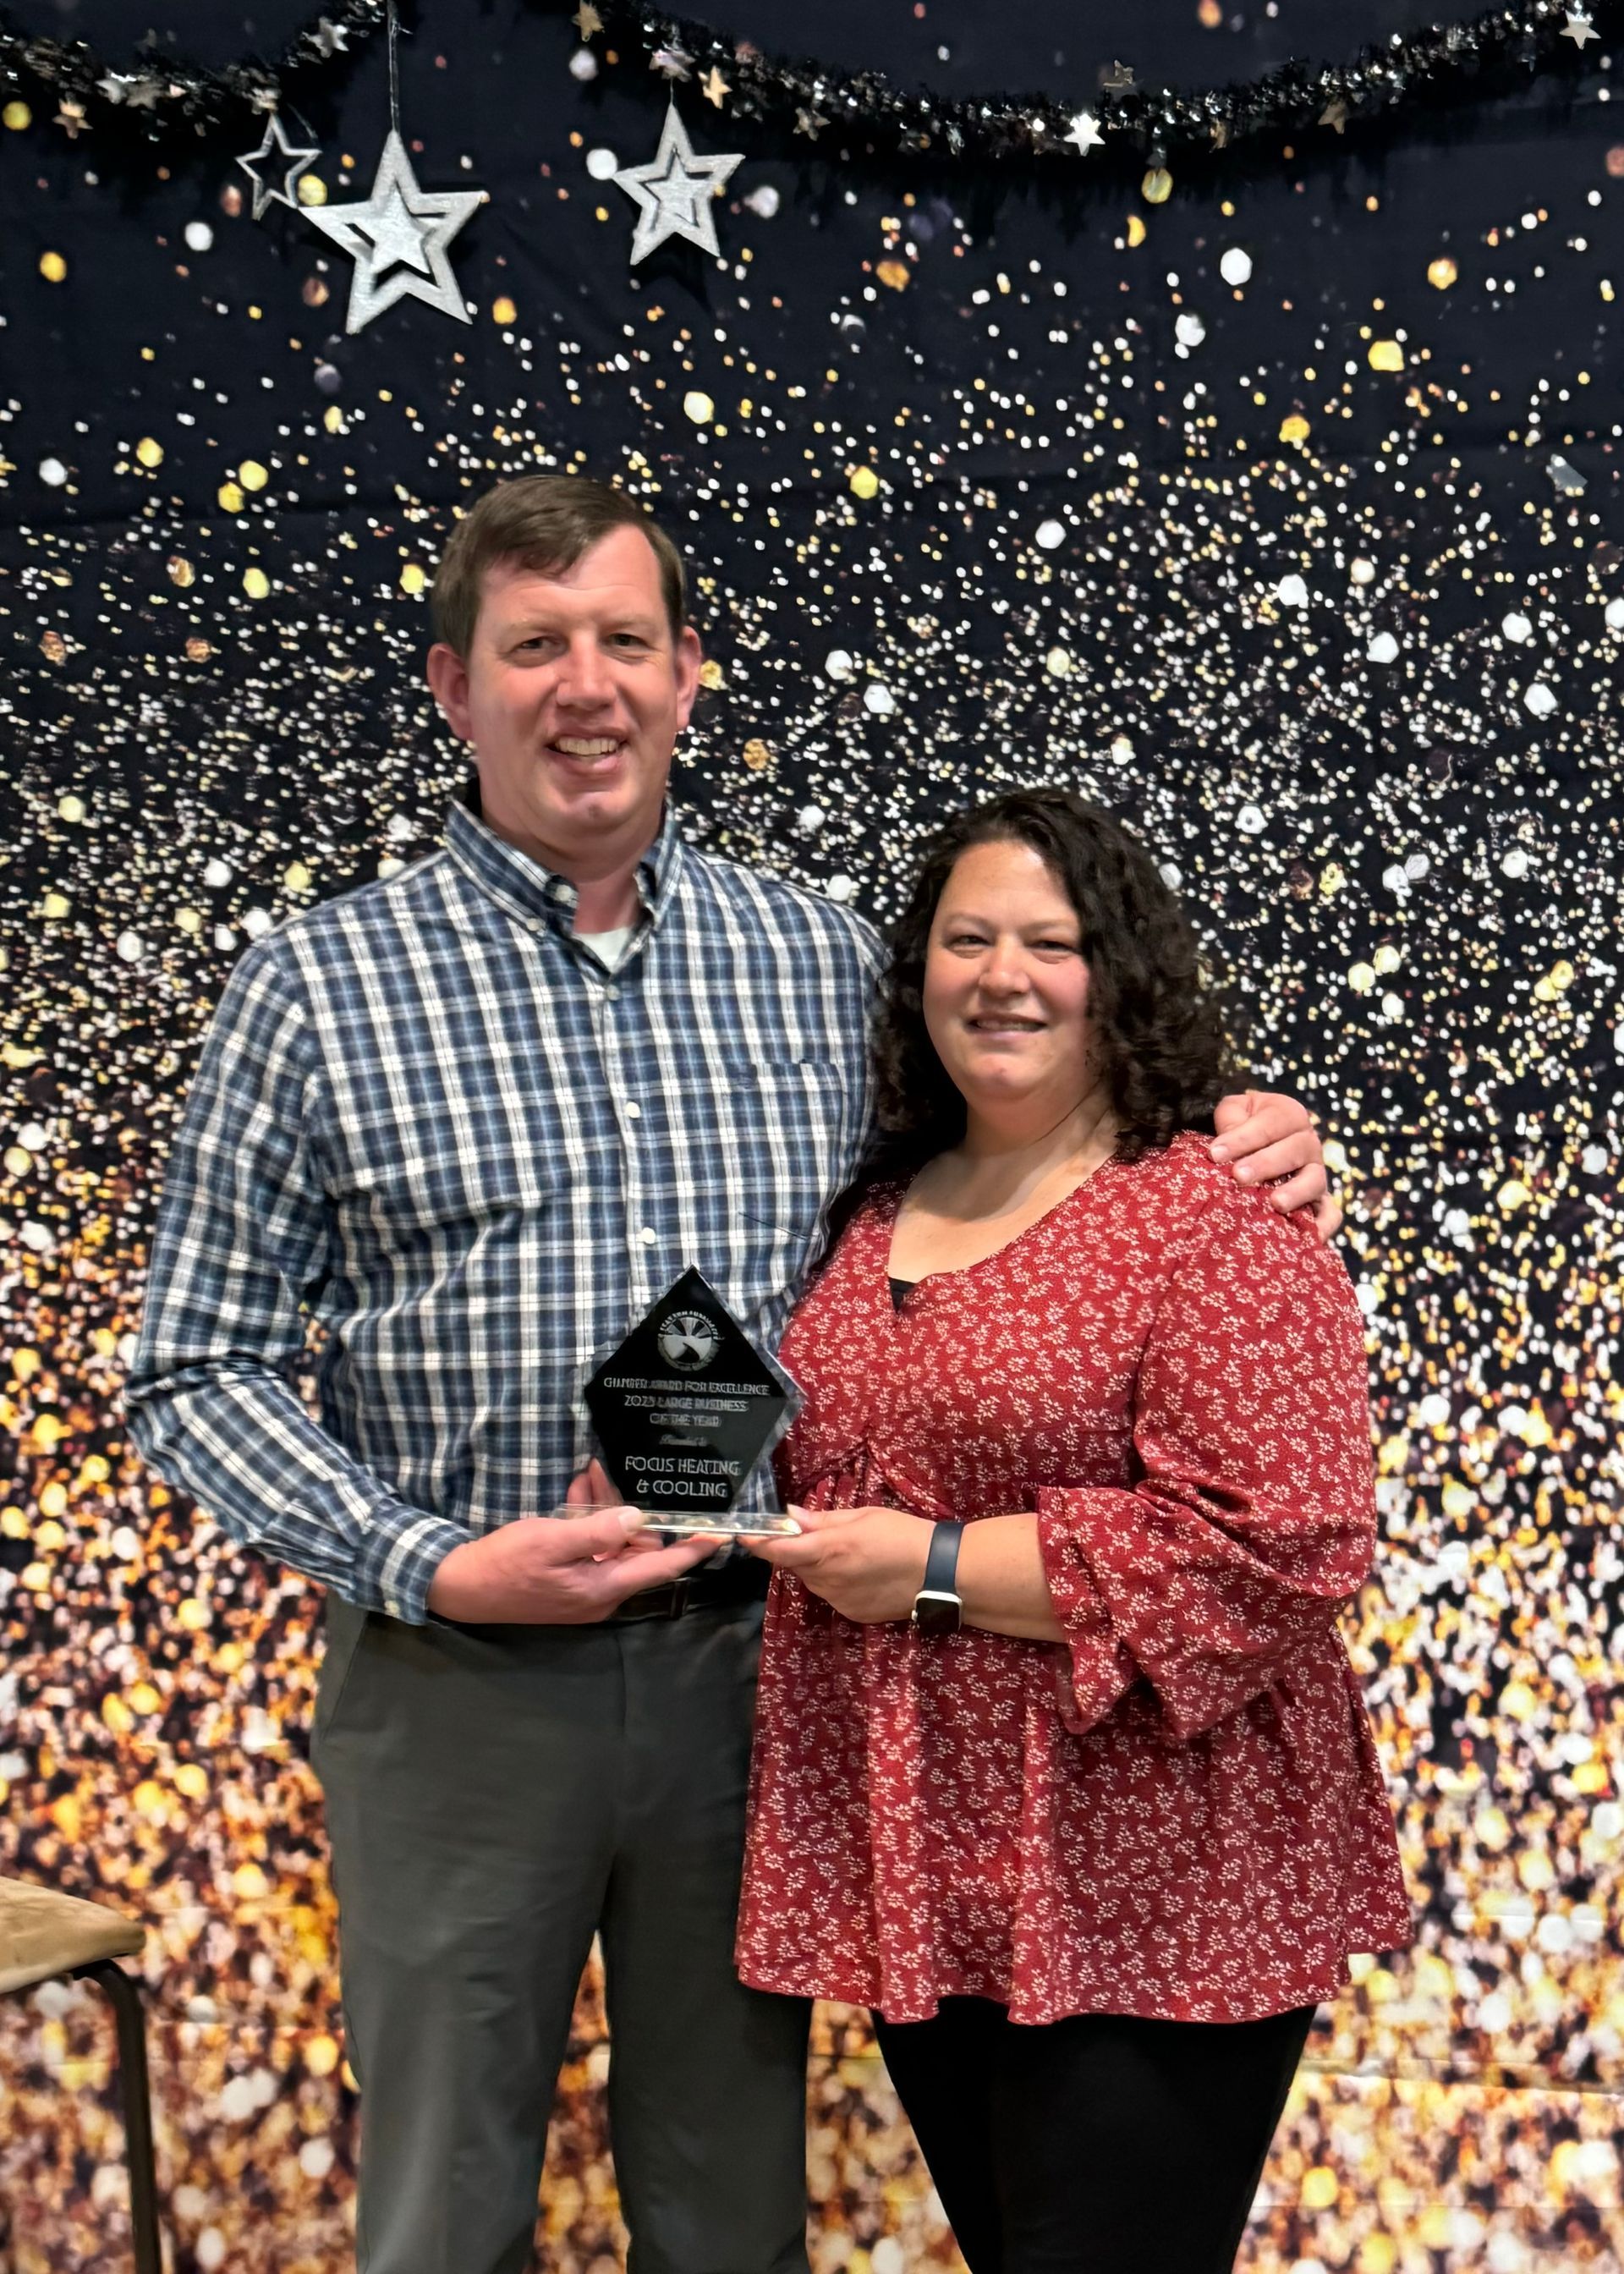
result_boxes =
[737,1137,1410,2022]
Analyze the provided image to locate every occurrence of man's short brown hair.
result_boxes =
[430,473,687,655]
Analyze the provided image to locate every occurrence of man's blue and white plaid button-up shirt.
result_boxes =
[128,805,878,1622]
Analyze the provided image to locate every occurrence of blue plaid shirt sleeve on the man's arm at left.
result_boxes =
[125,939,469,1623]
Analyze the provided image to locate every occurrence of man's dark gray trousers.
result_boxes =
[311,1599,809,2274]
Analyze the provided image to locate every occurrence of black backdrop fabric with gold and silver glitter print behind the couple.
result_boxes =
[0,0,1624,2274]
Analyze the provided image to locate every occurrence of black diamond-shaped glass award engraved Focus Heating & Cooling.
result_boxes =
[584,1269,801,1537]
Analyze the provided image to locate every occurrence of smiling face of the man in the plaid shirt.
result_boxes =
[428,528,700,873]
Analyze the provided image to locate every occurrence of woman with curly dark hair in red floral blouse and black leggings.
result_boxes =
[739,791,1410,2274]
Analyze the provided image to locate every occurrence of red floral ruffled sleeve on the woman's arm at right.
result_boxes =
[1037,1192,1376,1738]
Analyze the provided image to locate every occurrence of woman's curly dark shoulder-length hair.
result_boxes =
[869,789,1235,1176]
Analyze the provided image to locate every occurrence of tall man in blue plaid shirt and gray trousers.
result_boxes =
[129,477,1324,2274]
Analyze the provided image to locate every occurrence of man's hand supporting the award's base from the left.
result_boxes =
[428,1508,716,1626]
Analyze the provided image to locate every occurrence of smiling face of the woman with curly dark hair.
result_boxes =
[924,839,1094,1133]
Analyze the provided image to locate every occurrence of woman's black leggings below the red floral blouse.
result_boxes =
[874,1997,1314,2274]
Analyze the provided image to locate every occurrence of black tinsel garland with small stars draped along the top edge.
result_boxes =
[0,0,1624,166]
